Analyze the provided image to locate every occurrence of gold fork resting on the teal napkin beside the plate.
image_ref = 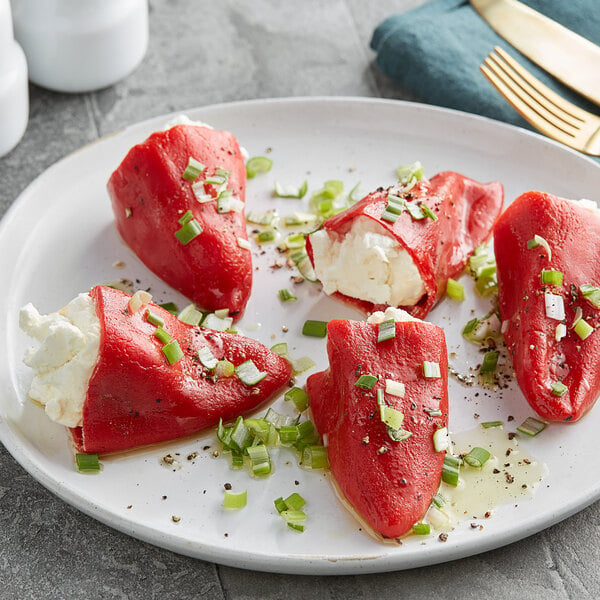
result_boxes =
[480,46,600,156]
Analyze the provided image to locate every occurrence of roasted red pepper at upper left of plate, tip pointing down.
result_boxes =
[108,125,252,317]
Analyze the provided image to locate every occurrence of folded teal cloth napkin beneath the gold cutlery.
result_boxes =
[371,0,600,127]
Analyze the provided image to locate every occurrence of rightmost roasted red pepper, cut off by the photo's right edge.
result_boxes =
[494,192,600,421]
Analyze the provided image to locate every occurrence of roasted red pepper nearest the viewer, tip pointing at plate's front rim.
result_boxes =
[307,320,448,538]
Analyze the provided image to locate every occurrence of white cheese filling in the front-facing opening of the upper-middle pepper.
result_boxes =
[310,216,425,306]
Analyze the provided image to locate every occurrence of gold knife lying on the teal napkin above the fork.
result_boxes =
[470,0,600,105]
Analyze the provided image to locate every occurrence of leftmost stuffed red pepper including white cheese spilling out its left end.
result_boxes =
[20,286,291,453]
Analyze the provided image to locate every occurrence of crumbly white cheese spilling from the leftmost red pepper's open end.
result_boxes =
[19,294,100,427]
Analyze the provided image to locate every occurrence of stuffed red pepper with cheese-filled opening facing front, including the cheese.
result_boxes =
[307,172,504,318]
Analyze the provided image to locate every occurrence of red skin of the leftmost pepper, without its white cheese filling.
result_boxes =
[71,286,291,452]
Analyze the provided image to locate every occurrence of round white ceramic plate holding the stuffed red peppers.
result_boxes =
[0,98,600,574]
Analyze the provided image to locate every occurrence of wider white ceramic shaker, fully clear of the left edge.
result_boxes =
[11,0,148,92]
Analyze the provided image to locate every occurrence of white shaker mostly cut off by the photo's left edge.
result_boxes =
[0,0,29,156]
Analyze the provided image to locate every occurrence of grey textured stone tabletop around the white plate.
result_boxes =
[0,0,600,600]
